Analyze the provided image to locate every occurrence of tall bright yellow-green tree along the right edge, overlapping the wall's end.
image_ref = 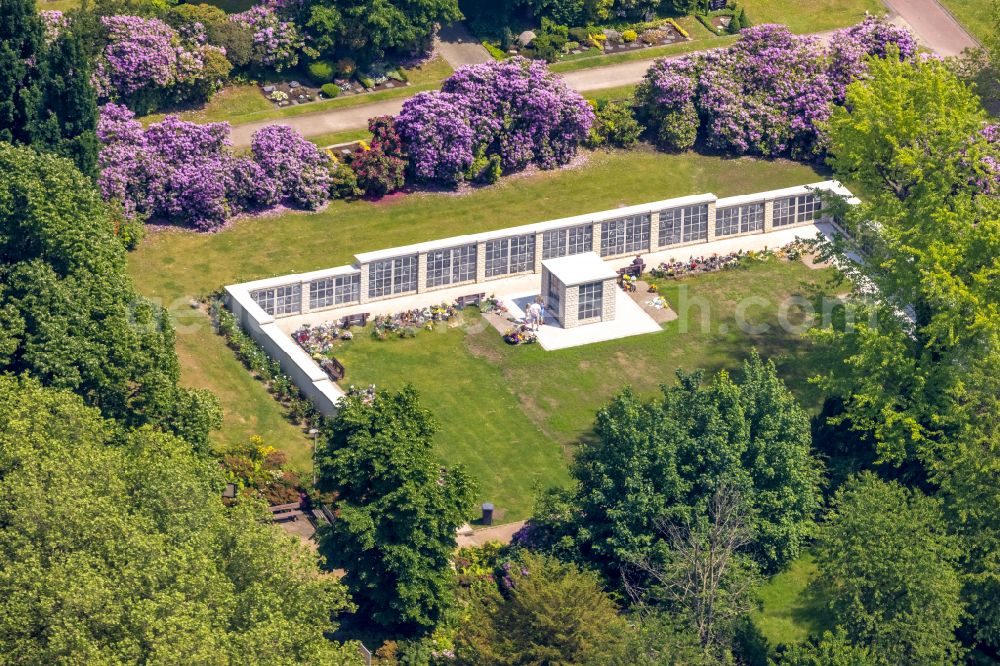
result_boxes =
[814,52,1000,647]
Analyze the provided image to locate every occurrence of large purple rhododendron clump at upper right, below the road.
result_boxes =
[636,17,916,158]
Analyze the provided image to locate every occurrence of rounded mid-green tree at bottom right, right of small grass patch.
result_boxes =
[816,472,964,665]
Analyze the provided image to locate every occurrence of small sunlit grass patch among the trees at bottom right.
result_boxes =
[753,553,832,649]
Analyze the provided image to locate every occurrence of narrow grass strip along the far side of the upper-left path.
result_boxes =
[140,57,452,125]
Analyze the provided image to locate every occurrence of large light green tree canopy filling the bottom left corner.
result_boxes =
[0,375,355,664]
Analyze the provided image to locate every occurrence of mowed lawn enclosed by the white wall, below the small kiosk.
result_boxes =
[336,259,833,520]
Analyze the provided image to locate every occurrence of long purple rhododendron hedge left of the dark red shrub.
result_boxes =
[97,104,329,230]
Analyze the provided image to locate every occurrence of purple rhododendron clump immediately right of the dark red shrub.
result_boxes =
[396,58,594,185]
